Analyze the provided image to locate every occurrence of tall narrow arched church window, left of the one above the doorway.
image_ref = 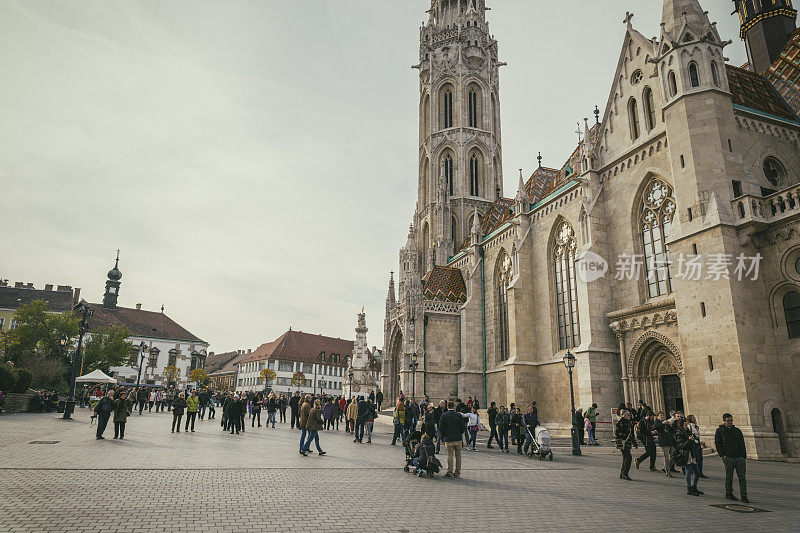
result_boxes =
[553,221,581,350]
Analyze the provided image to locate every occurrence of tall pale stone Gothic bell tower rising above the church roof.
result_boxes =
[414,0,504,276]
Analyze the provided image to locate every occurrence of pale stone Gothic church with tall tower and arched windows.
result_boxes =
[381,0,800,458]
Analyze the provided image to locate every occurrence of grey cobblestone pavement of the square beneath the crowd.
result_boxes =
[0,410,800,532]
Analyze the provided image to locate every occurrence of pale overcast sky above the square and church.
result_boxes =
[0,0,746,352]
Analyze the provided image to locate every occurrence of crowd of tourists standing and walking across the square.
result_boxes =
[81,387,748,502]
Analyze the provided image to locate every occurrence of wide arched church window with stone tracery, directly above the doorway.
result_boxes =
[639,178,675,298]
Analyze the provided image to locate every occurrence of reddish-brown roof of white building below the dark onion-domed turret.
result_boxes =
[89,304,205,343]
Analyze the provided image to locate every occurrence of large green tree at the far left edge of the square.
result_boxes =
[0,300,79,361]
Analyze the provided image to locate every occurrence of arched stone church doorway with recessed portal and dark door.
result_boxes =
[628,331,686,413]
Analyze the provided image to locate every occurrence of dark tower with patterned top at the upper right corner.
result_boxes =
[734,0,797,74]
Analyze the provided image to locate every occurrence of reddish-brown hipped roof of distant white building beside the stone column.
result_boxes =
[242,329,355,367]
